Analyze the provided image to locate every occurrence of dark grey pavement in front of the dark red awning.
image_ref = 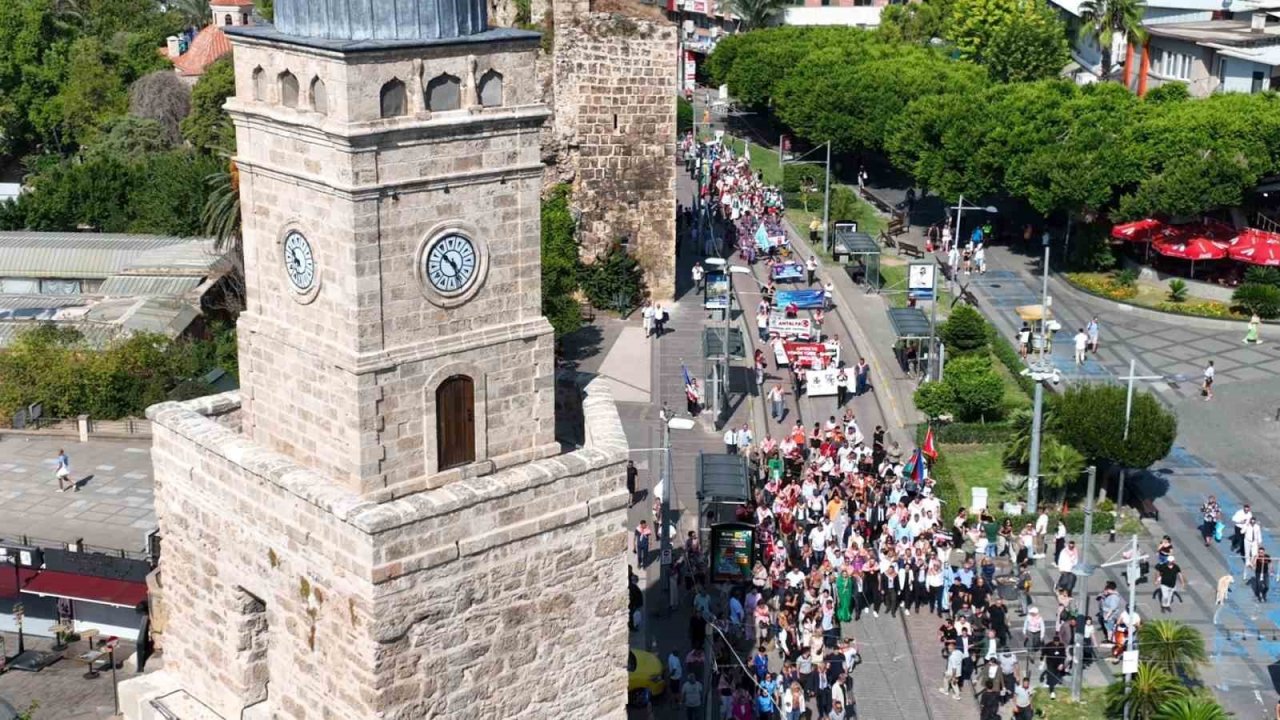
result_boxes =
[0,633,141,720]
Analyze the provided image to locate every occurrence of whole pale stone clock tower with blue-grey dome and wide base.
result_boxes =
[122,0,627,720]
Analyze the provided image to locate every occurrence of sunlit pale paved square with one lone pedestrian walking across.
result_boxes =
[0,434,156,552]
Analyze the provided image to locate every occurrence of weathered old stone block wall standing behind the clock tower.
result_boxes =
[550,9,678,300]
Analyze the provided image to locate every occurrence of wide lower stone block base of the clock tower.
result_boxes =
[122,383,627,720]
